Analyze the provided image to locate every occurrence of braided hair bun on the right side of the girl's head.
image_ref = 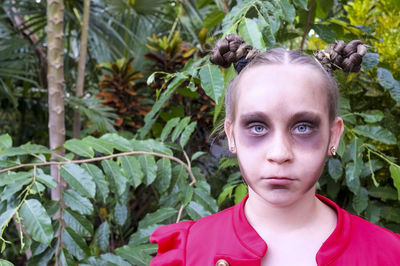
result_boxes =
[315,40,367,72]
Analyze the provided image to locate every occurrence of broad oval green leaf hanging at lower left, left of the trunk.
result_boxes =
[20,199,53,244]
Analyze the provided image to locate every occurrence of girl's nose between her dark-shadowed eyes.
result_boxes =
[266,133,293,164]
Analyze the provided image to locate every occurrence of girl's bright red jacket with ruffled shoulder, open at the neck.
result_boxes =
[150,195,400,266]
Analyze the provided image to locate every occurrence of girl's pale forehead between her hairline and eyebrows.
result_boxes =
[236,65,328,117]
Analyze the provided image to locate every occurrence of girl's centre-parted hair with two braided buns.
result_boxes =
[210,34,366,121]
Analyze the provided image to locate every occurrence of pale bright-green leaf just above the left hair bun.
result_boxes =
[239,18,265,49]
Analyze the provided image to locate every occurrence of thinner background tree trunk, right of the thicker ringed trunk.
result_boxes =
[73,0,90,138]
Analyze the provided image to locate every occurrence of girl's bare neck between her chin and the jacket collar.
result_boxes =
[244,188,329,233]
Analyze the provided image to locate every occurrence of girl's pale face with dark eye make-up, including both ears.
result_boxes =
[225,64,343,206]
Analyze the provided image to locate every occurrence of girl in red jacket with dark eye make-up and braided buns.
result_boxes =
[150,35,400,266]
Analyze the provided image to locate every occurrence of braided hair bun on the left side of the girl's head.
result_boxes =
[210,34,254,72]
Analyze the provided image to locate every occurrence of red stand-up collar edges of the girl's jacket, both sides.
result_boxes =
[232,194,351,265]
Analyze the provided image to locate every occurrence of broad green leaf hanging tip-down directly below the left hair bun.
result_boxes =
[199,64,224,104]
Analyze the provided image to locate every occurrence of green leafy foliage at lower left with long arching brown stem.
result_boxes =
[0,117,206,265]
